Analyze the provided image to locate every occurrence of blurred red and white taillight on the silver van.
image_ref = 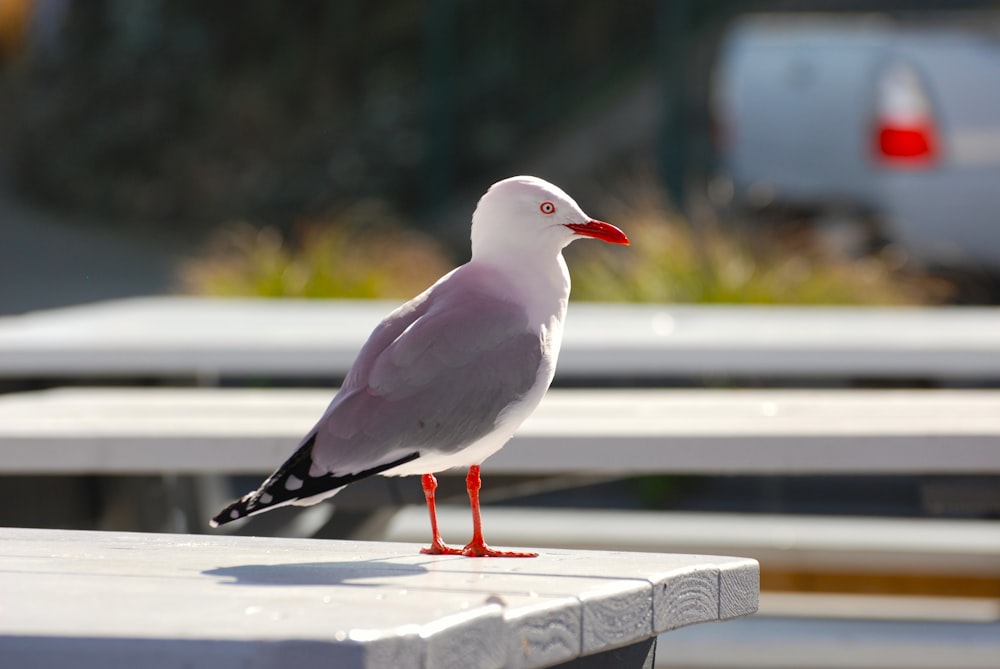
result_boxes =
[873,61,939,167]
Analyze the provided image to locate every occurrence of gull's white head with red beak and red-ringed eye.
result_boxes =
[472,176,629,257]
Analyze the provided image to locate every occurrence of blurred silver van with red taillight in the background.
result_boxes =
[712,12,1000,272]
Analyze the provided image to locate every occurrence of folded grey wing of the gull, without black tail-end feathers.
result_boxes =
[312,268,542,474]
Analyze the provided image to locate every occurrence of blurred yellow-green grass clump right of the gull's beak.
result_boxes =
[567,187,944,305]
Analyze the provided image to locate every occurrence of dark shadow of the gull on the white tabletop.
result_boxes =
[207,560,427,587]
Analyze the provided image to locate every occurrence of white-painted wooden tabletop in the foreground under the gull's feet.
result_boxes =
[0,528,758,667]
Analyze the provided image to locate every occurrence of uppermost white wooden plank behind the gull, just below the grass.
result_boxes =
[0,297,1000,382]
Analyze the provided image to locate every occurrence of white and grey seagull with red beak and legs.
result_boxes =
[211,176,629,557]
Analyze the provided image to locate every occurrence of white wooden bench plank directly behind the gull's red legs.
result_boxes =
[383,505,1000,576]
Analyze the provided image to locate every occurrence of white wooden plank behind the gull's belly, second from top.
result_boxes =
[0,388,1000,476]
